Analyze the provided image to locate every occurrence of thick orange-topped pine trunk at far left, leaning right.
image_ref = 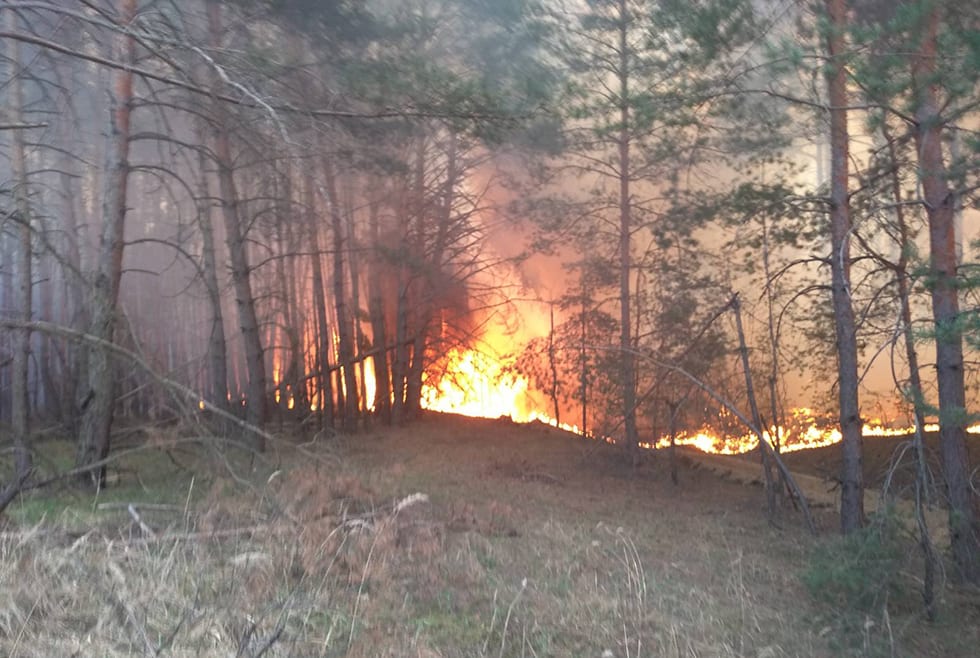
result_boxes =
[77,0,136,488]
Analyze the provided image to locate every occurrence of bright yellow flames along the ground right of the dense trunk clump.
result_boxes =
[422,348,980,455]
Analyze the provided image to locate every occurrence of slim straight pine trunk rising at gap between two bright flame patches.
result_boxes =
[618,0,639,460]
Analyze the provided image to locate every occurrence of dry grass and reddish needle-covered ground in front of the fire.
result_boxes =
[0,416,980,658]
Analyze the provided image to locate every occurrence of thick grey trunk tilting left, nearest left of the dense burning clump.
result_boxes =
[207,0,266,444]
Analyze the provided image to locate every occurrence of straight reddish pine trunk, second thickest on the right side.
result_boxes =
[827,0,864,534]
